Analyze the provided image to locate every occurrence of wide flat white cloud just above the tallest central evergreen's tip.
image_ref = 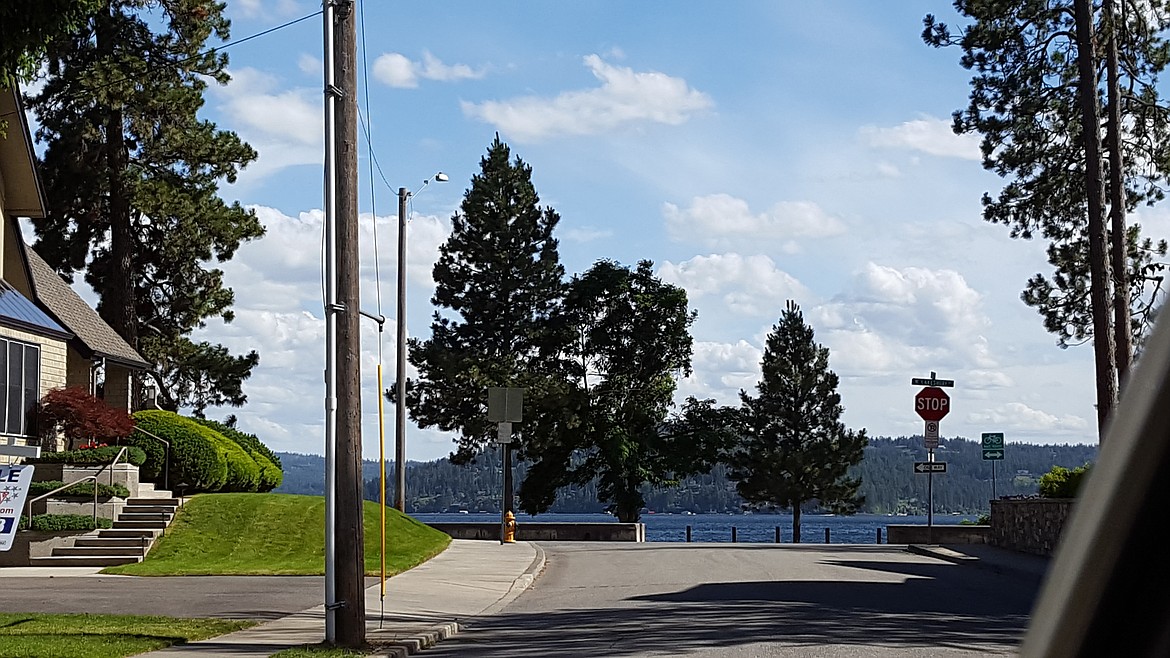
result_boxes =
[463,55,714,142]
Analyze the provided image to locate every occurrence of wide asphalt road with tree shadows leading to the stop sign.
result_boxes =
[426,542,1039,658]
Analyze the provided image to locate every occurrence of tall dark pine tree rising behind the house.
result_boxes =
[25,0,263,410]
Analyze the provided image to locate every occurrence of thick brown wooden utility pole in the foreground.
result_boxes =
[333,0,365,649]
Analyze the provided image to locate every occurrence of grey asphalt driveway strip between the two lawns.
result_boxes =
[0,576,378,621]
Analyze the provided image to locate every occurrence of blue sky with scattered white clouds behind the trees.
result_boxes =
[98,0,1170,459]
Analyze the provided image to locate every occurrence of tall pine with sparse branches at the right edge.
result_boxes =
[922,0,1170,435]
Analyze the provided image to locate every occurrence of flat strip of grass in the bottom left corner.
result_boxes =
[0,612,256,658]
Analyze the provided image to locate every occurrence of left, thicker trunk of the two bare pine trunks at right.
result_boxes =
[1074,0,1117,441]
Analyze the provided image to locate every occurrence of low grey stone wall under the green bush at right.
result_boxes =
[991,498,1073,556]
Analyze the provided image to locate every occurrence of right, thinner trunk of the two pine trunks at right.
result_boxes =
[1103,0,1134,388]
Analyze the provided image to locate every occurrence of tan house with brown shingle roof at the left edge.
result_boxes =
[0,89,150,462]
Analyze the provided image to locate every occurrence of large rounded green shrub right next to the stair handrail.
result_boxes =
[135,410,227,493]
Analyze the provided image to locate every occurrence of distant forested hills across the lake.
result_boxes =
[276,437,1096,514]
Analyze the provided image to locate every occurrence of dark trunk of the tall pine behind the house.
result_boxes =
[96,4,138,349]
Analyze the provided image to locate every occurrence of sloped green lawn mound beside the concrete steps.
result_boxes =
[102,494,450,576]
